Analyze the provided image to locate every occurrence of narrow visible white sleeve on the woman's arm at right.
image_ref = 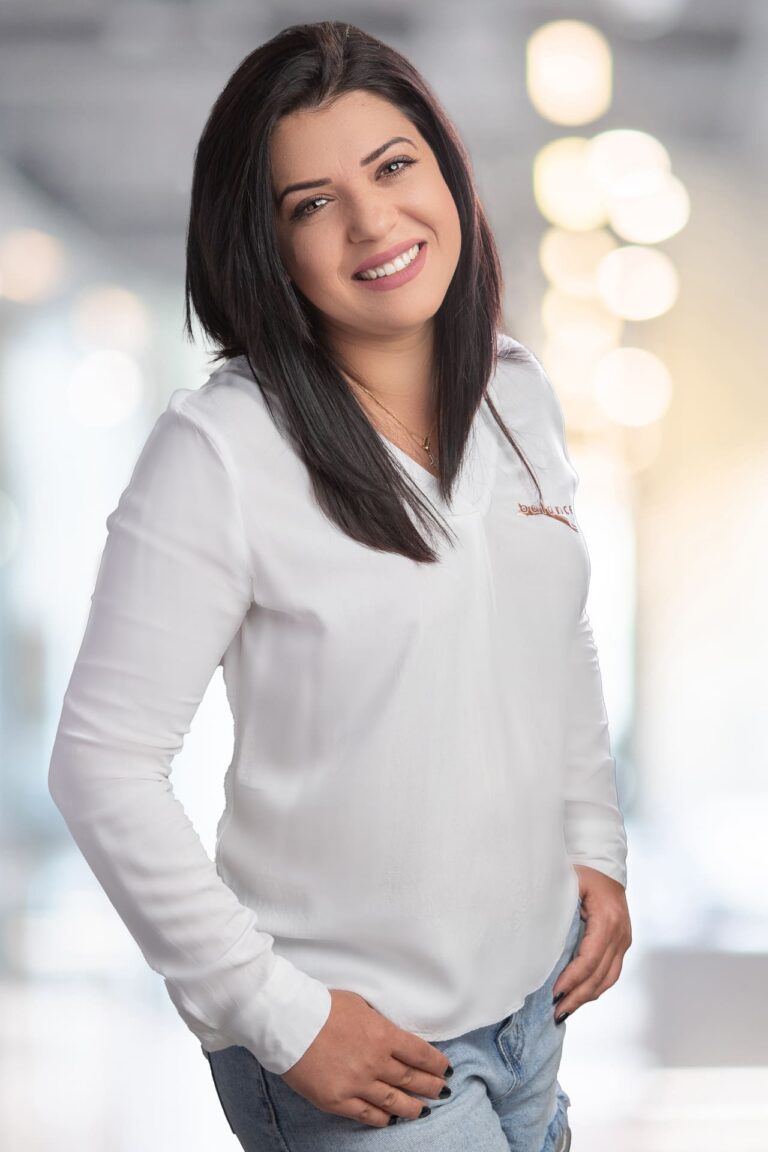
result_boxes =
[564,609,626,887]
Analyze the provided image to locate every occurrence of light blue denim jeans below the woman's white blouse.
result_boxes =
[203,900,585,1152]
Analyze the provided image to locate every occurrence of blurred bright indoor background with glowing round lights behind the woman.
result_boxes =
[0,0,768,1152]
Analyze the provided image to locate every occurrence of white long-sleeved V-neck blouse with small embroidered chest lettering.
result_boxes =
[48,334,626,1073]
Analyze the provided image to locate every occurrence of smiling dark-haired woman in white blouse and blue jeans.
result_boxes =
[50,22,631,1152]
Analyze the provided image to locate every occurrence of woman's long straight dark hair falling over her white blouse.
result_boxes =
[184,21,541,562]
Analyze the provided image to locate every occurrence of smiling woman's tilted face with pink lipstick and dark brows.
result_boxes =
[271,91,462,335]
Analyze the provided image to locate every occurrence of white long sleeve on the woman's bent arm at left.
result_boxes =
[48,389,332,1073]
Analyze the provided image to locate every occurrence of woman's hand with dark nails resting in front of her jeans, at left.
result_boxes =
[281,988,450,1128]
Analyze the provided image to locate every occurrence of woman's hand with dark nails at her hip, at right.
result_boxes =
[553,864,632,1023]
